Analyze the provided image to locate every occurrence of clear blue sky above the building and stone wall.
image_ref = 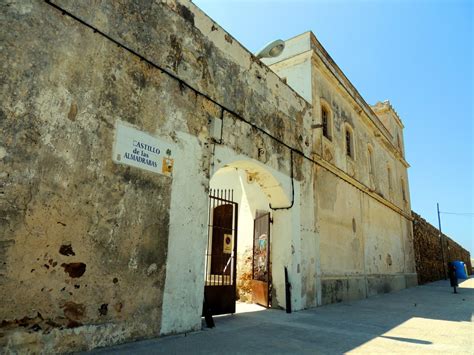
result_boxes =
[194,0,474,256]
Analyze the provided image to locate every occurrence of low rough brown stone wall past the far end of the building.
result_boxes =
[412,211,472,284]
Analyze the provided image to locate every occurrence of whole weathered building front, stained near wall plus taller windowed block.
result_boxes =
[0,0,422,352]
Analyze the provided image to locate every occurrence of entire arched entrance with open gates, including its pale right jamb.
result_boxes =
[205,159,291,314]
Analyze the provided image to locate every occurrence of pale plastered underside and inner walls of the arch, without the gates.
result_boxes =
[210,155,293,307]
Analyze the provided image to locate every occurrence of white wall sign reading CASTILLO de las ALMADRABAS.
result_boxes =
[112,121,174,177]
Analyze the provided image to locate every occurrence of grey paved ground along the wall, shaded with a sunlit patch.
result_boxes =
[90,279,474,354]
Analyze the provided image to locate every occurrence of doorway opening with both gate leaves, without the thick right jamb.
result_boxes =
[204,166,272,315]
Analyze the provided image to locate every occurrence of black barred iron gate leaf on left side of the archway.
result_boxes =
[203,190,238,315]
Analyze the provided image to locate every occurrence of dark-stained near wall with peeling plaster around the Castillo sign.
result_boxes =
[0,1,312,352]
